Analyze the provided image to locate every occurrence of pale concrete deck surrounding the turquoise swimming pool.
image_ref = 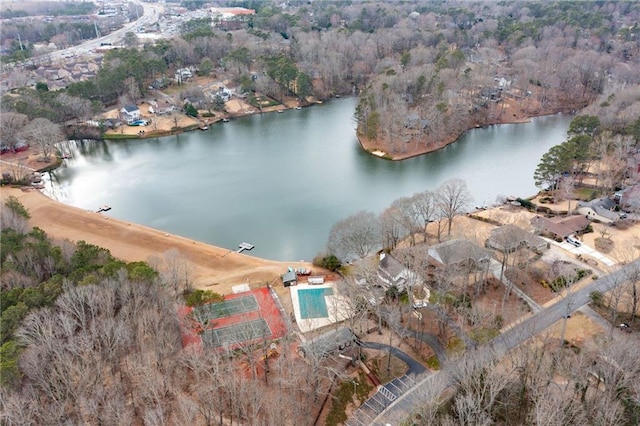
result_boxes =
[289,283,350,333]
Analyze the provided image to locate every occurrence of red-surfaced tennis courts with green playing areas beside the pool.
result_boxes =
[181,287,287,349]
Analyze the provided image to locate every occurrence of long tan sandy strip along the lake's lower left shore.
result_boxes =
[0,187,317,294]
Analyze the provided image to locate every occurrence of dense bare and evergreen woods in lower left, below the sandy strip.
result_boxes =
[0,198,350,425]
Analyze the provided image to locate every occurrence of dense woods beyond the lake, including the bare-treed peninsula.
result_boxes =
[2,1,640,158]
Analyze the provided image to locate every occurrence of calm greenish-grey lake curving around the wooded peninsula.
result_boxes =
[47,98,571,261]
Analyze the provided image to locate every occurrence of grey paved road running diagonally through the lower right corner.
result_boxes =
[362,259,640,426]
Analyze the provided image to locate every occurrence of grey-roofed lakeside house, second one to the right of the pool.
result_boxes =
[428,239,491,269]
